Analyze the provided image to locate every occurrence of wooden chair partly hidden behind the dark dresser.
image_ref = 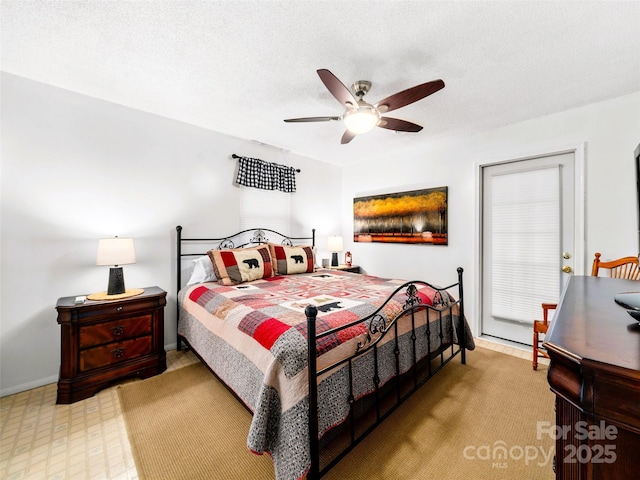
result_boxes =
[533,253,640,370]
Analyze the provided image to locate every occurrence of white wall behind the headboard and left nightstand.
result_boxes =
[0,74,340,395]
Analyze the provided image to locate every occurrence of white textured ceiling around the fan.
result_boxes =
[0,0,640,165]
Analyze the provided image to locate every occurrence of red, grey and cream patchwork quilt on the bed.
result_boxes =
[179,270,474,480]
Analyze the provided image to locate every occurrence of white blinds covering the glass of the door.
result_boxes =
[491,165,561,324]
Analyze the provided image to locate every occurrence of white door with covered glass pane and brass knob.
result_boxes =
[481,152,582,345]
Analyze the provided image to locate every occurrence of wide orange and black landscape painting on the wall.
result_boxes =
[353,187,448,245]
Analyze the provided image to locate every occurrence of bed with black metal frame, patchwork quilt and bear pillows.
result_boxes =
[176,226,474,480]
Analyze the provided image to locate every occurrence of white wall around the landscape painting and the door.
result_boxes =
[342,93,640,332]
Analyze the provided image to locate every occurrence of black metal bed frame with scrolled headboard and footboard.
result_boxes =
[176,226,466,480]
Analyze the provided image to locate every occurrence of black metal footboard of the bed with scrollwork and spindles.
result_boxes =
[305,267,467,480]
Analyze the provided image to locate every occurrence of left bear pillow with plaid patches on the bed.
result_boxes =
[208,245,273,285]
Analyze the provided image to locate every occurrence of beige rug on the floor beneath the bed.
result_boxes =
[119,348,554,480]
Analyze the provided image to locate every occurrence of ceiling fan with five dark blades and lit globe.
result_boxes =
[285,68,444,144]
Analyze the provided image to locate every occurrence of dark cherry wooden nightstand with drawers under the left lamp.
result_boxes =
[56,287,167,403]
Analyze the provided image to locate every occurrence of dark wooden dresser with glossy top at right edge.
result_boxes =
[544,276,640,480]
